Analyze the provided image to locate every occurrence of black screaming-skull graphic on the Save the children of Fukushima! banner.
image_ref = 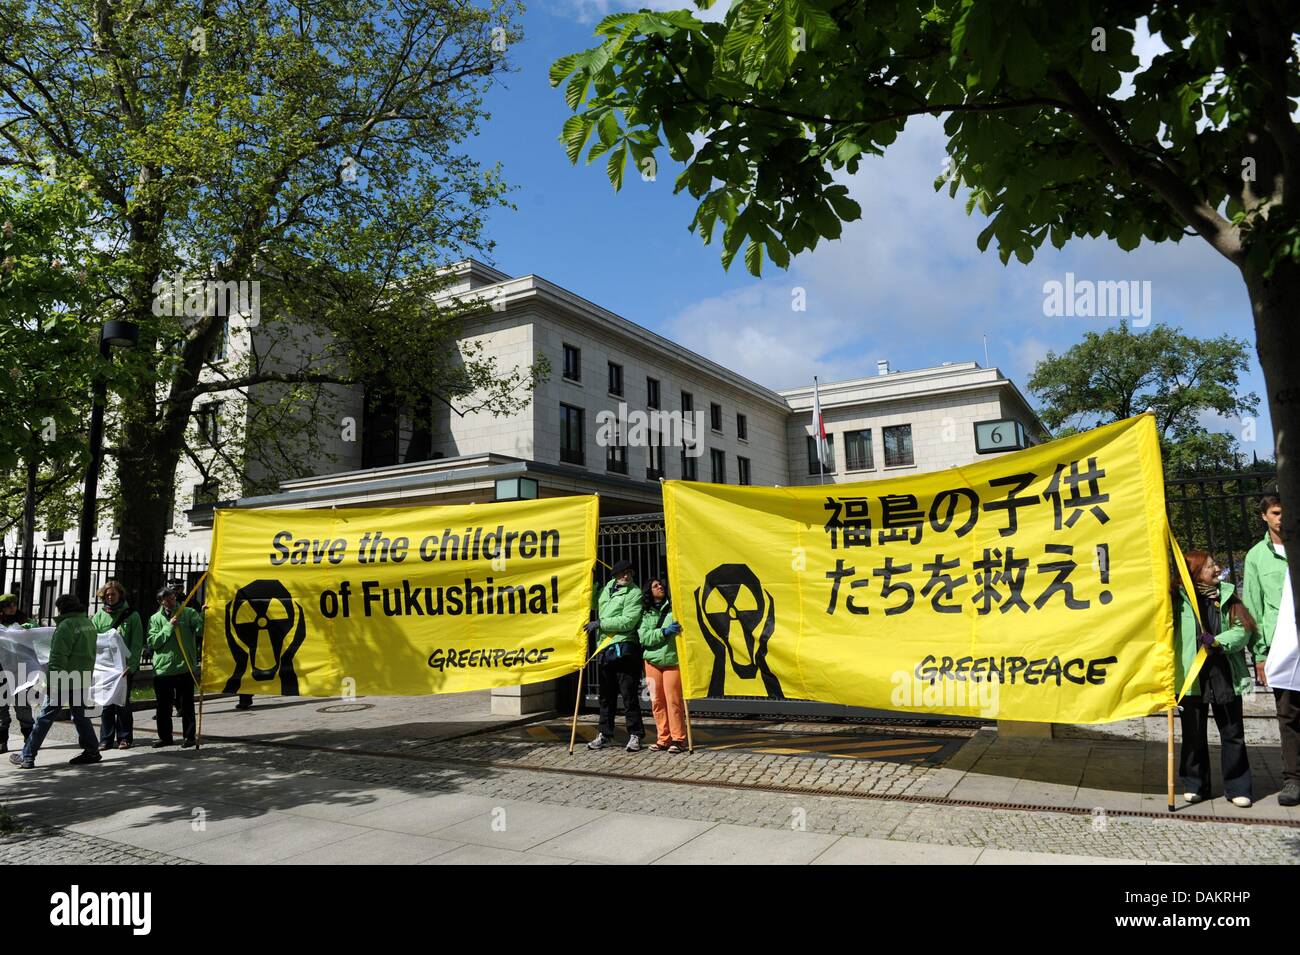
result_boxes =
[226,581,307,696]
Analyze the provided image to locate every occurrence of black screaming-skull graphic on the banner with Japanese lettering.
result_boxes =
[696,564,785,699]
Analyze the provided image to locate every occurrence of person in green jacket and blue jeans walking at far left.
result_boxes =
[9,594,103,769]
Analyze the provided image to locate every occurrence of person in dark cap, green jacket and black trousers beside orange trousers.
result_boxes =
[586,560,646,752]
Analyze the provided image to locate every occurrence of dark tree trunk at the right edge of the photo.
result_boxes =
[1243,264,1300,647]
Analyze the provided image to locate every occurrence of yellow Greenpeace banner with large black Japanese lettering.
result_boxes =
[664,416,1174,722]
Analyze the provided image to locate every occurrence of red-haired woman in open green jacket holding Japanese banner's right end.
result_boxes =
[1174,550,1256,808]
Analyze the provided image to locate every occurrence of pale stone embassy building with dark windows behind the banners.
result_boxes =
[226,261,1047,530]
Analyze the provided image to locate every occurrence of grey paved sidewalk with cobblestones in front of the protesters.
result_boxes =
[0,694,1300,864]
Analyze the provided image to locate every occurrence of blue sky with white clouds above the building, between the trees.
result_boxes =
[471,0,1271,457]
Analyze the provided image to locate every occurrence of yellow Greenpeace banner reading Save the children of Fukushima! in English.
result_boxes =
[203,496,598,696]
